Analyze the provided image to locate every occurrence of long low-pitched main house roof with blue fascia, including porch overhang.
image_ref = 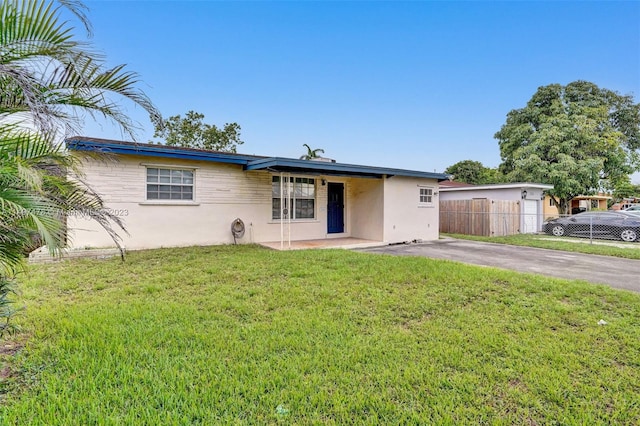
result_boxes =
[66,136,449,181]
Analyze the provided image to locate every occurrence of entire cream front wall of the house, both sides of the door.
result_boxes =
[68,156,438,249]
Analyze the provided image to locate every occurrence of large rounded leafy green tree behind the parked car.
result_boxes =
[495,81,640,213]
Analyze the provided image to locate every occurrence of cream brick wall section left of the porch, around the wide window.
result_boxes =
[69,157,271,248]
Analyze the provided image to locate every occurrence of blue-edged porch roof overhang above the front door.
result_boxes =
[245,157,449,180]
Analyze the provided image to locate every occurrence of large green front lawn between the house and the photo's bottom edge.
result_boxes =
[0,246,640,425]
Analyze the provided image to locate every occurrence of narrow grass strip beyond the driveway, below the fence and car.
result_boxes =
[442,234,640,260]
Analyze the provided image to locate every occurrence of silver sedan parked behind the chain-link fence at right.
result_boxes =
[542,211,640,242]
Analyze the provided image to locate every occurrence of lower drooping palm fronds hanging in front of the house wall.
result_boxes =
[0,125,126,276]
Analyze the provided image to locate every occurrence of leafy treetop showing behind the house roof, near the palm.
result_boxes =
[153,111,244,152]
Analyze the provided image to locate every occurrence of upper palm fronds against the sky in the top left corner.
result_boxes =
[0,0,162,137]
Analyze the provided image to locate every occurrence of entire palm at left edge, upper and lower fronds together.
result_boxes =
[0,0,161,279]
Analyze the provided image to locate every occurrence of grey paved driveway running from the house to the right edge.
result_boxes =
[358,239,640,292]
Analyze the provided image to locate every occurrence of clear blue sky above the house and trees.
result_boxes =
[82,1,640,181]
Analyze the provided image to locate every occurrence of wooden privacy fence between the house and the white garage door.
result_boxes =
[440,199,520,237]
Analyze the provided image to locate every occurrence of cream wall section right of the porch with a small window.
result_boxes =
[383,176,439,243]
